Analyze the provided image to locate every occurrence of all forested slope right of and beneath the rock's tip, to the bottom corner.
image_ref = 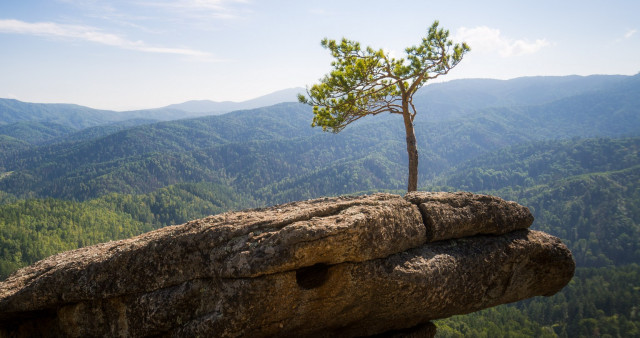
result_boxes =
[432,138,640,337]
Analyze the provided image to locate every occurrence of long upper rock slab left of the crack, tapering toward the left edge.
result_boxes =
[0,194,426,319]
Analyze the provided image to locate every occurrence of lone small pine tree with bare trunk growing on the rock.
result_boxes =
[298,21,470,191]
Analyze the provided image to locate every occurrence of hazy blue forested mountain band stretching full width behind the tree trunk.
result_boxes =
[0,70,640,203]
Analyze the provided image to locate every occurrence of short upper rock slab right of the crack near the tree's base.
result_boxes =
[405,192,533,242]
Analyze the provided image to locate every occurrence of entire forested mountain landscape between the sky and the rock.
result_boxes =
[0,75,640,337]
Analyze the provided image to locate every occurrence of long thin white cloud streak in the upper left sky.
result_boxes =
[0,20,214,61]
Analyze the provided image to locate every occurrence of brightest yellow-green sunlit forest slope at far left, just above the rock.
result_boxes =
[0,199,151,278]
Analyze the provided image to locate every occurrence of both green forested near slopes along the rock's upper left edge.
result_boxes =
[0,183,256,279]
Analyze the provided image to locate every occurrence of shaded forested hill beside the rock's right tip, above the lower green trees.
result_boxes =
[440,138,640,267]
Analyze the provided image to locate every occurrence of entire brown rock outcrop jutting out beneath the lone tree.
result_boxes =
[0,193,575,337]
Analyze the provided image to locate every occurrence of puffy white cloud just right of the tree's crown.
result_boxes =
[454,26,549,58]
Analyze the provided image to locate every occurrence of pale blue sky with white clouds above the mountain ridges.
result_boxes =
[0,0,640,110]
